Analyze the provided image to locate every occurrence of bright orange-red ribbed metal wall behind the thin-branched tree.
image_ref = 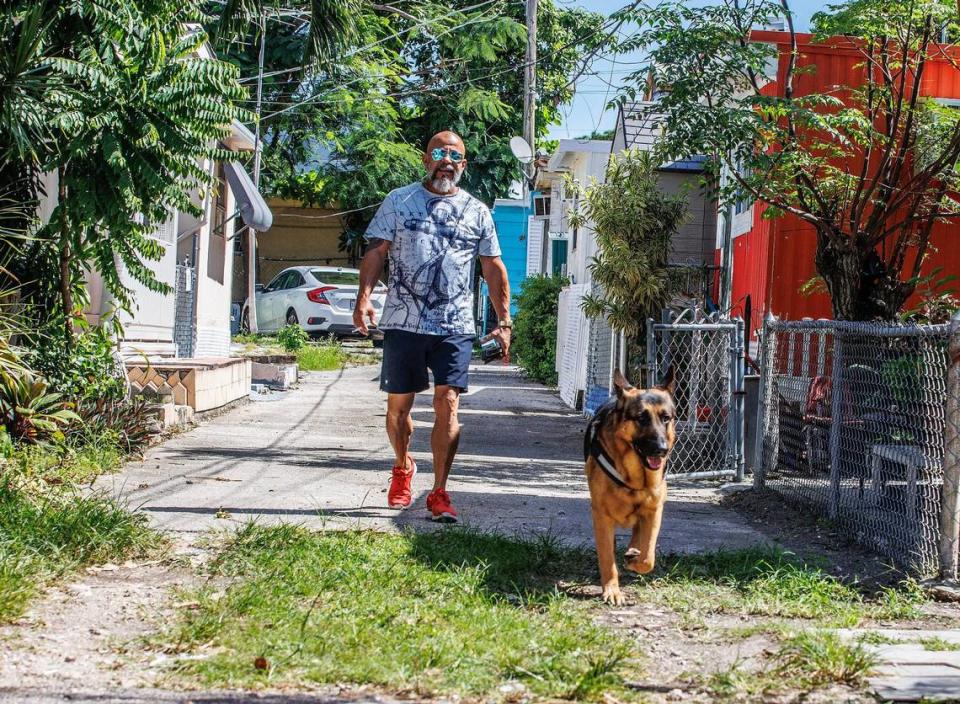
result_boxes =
[732,31,960,327]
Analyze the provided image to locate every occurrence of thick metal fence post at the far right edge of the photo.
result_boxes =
[940,312,960,580]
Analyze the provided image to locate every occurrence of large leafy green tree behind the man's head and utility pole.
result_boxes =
[228,0,611,228]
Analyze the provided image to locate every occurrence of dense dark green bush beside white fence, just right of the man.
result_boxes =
[510,276,570,386]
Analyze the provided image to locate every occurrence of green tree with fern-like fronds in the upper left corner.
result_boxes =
[0,0,243,332]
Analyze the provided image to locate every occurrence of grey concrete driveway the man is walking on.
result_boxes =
[100,366,765,552]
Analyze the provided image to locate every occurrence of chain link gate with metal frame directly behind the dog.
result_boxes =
[647,319,744,481]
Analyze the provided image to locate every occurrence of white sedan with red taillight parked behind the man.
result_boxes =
[241,266,387,335]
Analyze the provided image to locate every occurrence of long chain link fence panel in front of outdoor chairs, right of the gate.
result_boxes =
[754,319,960,574]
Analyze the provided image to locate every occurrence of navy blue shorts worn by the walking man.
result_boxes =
[380,330,474,394]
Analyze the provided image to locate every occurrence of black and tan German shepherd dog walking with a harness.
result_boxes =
[583,367,676,605]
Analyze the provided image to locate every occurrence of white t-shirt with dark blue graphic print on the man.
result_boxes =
[366,183,500,335]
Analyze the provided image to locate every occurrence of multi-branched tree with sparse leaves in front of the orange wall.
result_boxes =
[624,0,960,320]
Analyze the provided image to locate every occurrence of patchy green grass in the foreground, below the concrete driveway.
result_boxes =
[152,525,922,701]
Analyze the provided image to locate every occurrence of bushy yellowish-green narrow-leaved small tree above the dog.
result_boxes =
[570,150,687,338]
